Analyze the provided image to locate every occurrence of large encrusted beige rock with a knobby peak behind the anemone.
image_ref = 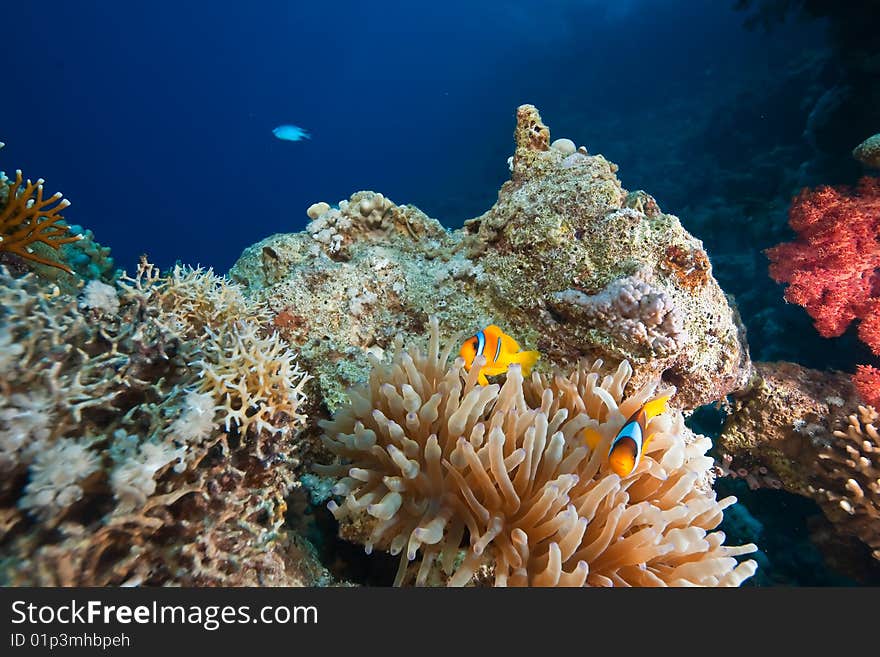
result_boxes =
[230,105,750,410]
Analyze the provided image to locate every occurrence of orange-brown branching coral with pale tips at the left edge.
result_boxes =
[0,170,83,273]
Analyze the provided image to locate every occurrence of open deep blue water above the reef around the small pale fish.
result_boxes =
[0,0,818,271]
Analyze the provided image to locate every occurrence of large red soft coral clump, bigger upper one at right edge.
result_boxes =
[766,177,880,348]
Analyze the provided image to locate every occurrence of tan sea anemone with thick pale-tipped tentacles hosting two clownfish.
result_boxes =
[315,317,756,586]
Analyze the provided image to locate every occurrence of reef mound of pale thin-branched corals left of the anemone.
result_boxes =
[0,261,332,585]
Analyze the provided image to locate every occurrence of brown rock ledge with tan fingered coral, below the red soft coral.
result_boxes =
[718,362,880,558]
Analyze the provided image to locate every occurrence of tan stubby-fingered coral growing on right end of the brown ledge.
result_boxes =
[809,406,880,559]
